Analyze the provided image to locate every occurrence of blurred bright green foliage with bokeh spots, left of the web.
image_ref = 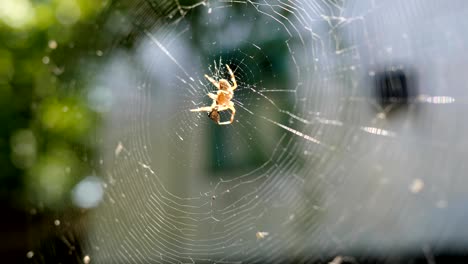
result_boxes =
[0,0,106,209]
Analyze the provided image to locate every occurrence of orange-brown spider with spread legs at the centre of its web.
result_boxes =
[190,64,237,125]
